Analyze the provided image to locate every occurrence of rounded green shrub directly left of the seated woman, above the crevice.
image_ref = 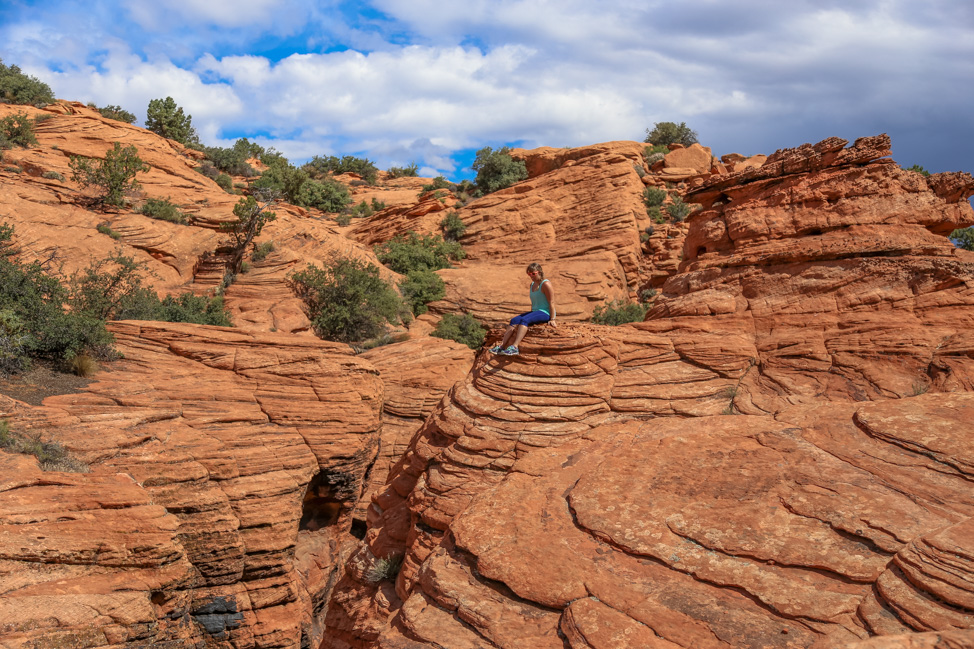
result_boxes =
[288,257,402,343]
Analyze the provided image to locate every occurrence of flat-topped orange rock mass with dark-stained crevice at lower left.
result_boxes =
[0,322,382,647]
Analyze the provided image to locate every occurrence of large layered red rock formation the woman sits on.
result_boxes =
[323,136,974,649]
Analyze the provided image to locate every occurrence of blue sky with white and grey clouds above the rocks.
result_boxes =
[0,0,974,180]
